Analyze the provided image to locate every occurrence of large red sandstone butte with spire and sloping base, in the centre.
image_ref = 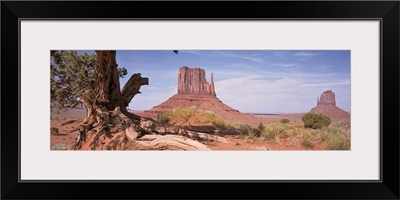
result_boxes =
[145,66,253,121]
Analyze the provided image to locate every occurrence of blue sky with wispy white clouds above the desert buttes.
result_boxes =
[79,50,350,113]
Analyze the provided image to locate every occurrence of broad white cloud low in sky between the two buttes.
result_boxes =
[215,72,350,113]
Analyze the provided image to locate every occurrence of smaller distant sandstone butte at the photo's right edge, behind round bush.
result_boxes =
[310,90,350,119]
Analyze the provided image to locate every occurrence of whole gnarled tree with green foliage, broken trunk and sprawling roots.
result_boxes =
[51,51,226,150]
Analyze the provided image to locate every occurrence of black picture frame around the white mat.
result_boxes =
[1,1,400,199]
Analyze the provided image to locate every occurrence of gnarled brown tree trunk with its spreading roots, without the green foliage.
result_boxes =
[74,51,223,150]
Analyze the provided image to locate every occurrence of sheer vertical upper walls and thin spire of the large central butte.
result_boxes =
[178,66,216,96]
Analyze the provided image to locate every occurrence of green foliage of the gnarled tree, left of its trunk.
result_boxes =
[50,51,128,109]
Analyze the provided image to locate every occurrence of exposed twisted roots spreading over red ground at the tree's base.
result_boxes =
[71,108,230,150]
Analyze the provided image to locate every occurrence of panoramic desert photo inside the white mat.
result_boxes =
[50,49,351,151]
